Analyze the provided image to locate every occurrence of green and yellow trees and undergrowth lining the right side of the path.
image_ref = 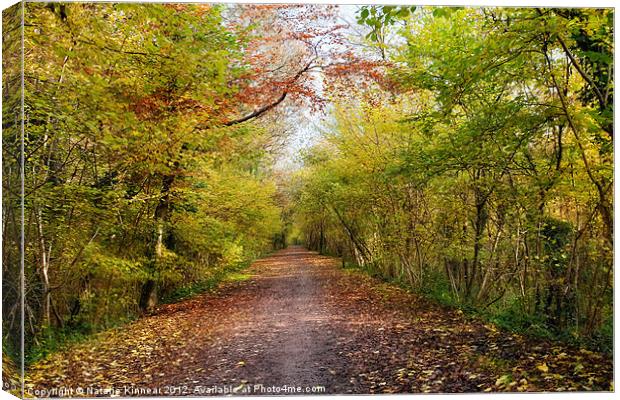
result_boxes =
[294,6,613,350]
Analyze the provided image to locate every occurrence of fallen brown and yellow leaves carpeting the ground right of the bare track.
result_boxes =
[332,273,613,393]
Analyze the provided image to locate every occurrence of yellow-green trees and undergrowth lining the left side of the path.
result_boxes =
[3,3,282,358]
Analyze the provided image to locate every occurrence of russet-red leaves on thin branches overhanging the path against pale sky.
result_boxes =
[222,5,384,122]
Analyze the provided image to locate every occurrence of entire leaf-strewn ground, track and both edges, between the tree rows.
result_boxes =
[26,247,613,397]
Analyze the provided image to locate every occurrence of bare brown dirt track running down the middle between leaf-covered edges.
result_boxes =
[184,247,346,392]
